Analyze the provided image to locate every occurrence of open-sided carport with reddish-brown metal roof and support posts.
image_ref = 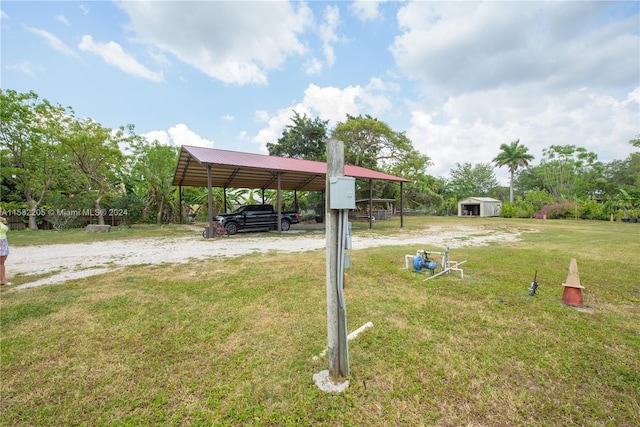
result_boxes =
[173,145,409,232]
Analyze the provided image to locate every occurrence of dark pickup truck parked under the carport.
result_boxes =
[215,205,300,235]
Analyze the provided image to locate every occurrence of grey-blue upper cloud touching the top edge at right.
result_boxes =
[391,2,638,94]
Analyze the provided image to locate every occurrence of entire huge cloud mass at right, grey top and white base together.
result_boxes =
[390,2,640,181]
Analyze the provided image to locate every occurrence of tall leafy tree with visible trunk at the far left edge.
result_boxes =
[0,89,68,230]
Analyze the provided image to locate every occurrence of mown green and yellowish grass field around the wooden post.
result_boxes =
[0,218,640,426]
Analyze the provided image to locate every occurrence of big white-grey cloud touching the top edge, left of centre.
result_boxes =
[118,1,312,84]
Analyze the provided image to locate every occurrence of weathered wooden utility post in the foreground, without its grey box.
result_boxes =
[325,140,349,379]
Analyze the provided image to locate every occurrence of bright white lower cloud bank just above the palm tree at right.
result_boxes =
[407,87,640,185]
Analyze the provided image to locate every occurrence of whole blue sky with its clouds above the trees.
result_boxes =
[0,0,640,184]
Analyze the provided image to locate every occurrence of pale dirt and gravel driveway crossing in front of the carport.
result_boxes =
[7,226,520,290]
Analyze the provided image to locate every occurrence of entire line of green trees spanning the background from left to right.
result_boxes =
[0,89,640,230]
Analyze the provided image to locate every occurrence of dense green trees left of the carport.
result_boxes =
[0,90,177,230]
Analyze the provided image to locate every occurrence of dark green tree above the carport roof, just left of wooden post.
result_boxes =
[267,111,329,161]
